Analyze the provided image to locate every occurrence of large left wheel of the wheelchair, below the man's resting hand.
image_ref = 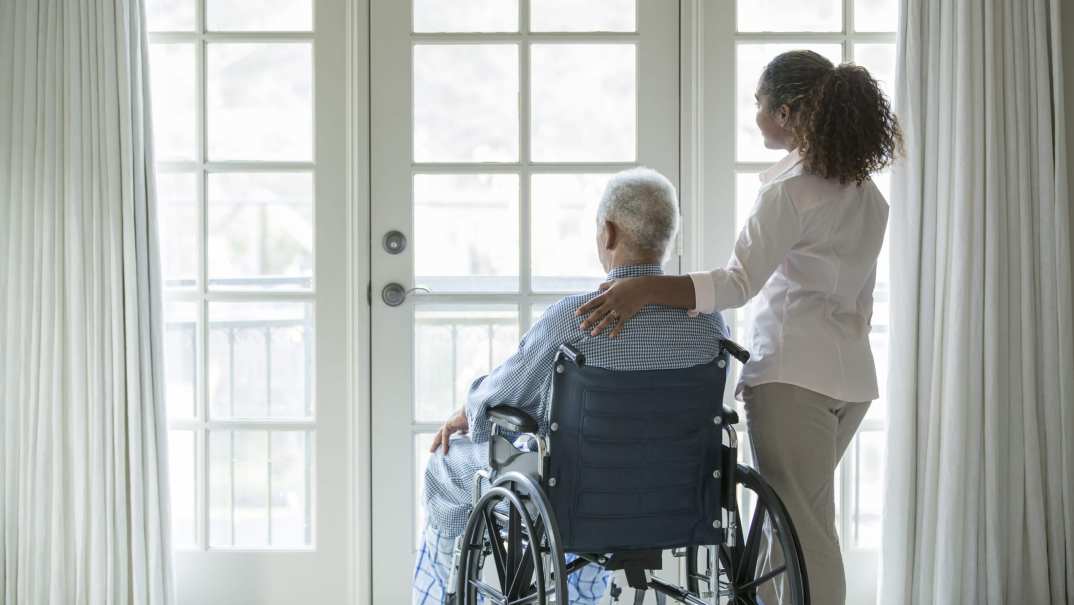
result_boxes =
[455,485,568,605]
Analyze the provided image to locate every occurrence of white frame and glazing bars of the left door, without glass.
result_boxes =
[157,0,361,603]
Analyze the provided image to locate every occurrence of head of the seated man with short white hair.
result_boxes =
[597,168,679,271]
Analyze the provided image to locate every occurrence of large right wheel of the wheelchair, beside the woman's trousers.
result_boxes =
[686,465,810,605]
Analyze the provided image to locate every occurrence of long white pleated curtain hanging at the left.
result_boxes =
[0,0,172,605]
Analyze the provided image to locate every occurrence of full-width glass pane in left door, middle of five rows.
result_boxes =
[208,172,314,290]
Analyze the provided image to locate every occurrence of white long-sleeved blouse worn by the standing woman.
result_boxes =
[690,152,887,402]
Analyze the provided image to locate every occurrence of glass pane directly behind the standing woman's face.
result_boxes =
[736,44,843,161]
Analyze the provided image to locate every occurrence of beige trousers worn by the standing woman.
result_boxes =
[742,383,869,605]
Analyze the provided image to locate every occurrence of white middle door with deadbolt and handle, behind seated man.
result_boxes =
[369,0,680,603]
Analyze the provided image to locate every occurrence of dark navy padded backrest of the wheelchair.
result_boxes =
[545,348,727,552]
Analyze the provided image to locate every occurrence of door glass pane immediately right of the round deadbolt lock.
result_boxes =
[413,174,519,292]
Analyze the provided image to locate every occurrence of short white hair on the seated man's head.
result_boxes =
[597,168,679,261]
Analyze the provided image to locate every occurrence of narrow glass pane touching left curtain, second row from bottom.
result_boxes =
[164,302,198,418]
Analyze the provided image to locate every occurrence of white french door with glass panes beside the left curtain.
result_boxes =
[145,0,353,605]
